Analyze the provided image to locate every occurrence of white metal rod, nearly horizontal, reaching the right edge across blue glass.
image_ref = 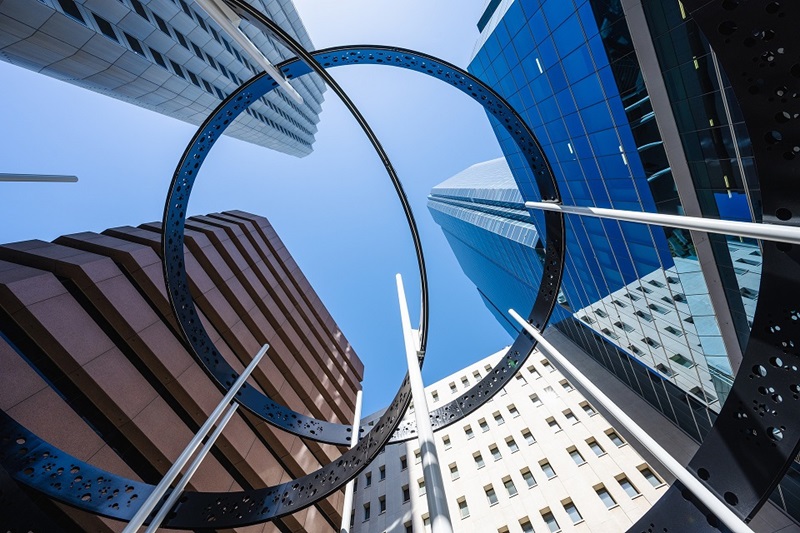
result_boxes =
[525,202,800,244]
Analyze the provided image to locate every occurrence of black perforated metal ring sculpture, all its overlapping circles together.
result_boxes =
[0,0,800,532]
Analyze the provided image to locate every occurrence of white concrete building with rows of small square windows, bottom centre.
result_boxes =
[351,350,667,533]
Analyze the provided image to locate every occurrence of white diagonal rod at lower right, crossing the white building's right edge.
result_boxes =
[508,309,752,533]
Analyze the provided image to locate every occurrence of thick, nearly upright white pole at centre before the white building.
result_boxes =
[397,274,453,533]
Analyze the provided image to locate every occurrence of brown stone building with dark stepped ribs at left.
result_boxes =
[0,212,363,531]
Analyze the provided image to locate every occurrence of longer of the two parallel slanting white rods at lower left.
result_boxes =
[122,344,269,533]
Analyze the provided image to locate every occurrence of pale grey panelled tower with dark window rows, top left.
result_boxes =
[0,0,325,156]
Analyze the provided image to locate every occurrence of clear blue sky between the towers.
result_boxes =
[0,0,510,414]
